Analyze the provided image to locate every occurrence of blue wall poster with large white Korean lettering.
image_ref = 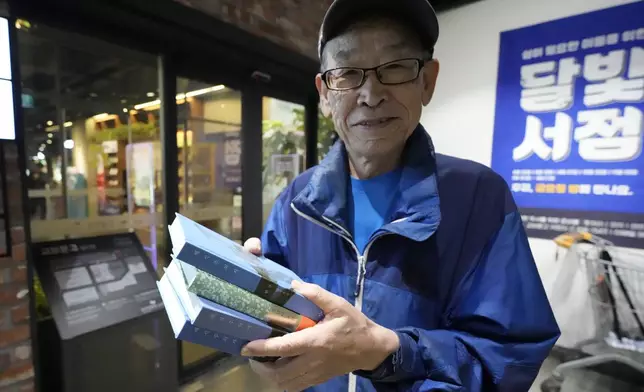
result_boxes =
[492,1,644,247]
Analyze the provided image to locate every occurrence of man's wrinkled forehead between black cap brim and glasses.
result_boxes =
[324,17,422,67]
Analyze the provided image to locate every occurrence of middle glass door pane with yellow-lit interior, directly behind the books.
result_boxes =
[176,78,242,370]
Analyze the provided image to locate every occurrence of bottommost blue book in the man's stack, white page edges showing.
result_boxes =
[157,276,249,356]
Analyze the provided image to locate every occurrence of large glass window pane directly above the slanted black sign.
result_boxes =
[18,25,167,266]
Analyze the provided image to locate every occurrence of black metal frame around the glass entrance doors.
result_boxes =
[9,0,319,384]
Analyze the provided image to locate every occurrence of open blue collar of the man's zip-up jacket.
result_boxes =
[292,124,441,241]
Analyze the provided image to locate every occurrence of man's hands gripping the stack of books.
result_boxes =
[242,239,400,392]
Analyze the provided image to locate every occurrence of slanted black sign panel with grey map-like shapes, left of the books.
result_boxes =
[33,233,163,339]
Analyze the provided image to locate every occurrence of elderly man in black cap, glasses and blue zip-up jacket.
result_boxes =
[243,0,559,392]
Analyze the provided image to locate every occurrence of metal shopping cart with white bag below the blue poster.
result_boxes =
[541,233,644,392]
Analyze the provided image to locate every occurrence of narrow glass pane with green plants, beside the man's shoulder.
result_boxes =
[262,97,306,224]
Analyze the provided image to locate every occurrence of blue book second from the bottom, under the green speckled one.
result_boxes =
[163,260,287,341]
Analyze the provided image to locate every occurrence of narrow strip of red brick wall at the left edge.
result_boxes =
[0,144,34,392]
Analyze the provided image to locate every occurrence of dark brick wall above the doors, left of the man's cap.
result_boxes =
[175,0,332,59]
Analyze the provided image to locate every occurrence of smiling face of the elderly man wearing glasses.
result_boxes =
[316,19,438,161]
